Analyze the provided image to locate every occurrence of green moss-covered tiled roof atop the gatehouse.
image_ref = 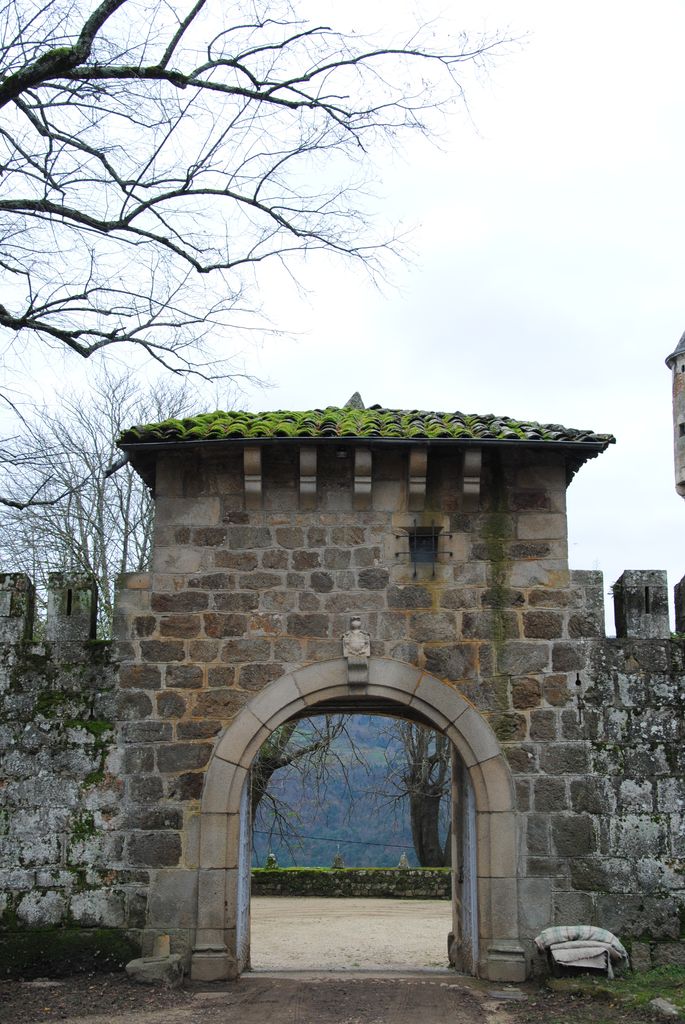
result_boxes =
[119,406,614,449]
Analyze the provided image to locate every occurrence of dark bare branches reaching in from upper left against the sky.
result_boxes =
[0,0,500,385]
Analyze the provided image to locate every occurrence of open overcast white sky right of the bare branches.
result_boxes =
[232,0,685,630]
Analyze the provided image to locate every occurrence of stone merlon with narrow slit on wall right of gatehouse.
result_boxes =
[612,569,671,640]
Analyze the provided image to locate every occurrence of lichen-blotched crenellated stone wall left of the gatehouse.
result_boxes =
[0,574,147,973]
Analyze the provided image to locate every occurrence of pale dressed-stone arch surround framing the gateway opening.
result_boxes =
[191,657,525,981]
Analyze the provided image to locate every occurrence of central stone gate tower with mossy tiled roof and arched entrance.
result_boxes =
[117,397,610,981]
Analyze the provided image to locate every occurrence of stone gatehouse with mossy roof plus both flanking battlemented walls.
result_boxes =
[0,395,685,980]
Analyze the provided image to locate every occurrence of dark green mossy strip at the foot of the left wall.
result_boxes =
[0,928,140,978]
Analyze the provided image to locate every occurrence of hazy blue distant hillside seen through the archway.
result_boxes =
[253,716,446,867]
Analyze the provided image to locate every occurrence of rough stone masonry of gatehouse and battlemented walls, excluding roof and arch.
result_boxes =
[0,444,685,964]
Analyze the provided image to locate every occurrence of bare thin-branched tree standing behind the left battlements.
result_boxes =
[0,370,190,635]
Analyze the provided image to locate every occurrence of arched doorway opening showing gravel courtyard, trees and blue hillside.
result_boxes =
[250,714,453,970]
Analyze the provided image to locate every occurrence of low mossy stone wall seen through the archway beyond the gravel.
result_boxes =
[252,867,452,899]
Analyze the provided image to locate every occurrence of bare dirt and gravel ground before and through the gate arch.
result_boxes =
[0,898,671,1024]
